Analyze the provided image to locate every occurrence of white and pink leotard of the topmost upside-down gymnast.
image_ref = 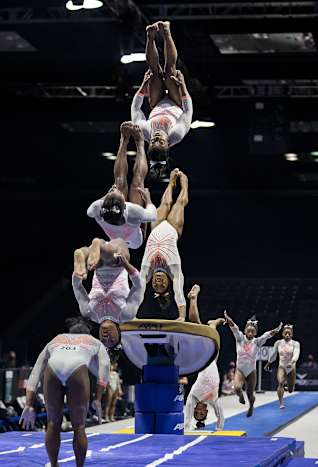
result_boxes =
[131,92,193,146]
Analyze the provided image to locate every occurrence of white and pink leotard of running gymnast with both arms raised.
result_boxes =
[230,324,271,378]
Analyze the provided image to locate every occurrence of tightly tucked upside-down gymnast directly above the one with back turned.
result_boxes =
[72,239,143,348]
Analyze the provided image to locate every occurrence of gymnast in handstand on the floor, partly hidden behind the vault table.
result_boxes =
[184,284,225,430]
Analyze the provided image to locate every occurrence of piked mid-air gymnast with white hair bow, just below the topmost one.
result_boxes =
[87,122,156,249]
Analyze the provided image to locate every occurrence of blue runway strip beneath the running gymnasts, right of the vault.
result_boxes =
[205,392,318,436]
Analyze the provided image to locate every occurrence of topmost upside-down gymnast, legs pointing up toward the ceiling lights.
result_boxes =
[131,21,193,178]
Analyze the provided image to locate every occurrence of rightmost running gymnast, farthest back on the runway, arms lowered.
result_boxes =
[264,324,300,409]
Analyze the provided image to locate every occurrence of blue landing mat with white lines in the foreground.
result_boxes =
[0,432,296,467]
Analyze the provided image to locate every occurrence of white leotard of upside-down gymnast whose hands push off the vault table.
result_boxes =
[140,221,186,306]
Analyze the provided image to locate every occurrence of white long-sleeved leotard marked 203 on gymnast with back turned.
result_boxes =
[27,334,110,392]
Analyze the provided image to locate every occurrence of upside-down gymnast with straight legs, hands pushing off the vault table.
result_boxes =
[140,169,188,320]
